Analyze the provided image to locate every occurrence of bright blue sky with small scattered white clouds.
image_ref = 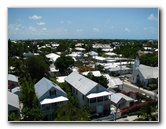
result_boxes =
[8,8,159,40]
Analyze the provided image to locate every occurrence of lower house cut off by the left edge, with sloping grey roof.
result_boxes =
[8,91,20,117]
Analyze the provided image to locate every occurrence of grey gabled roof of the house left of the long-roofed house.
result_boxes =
[35,77,66,98]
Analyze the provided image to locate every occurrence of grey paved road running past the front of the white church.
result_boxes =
[120,81,158,99]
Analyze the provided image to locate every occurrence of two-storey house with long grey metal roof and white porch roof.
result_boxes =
[65,72,111,113]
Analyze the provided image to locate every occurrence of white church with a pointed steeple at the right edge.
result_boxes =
[131,58,159,87]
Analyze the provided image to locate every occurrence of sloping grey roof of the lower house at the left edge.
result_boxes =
[8,91,19,109]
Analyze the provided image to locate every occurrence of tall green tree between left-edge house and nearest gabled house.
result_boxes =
[21,78,44,121]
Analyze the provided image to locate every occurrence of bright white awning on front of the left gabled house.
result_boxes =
[40,96,69,105]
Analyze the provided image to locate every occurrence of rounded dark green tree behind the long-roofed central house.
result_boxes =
[55,55,74,73]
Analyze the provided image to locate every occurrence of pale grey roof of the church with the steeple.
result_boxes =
[139,64,159,79]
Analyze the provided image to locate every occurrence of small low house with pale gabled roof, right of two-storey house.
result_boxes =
[111,93,134,108]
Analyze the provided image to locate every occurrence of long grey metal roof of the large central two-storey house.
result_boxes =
[65,72,99,95]
